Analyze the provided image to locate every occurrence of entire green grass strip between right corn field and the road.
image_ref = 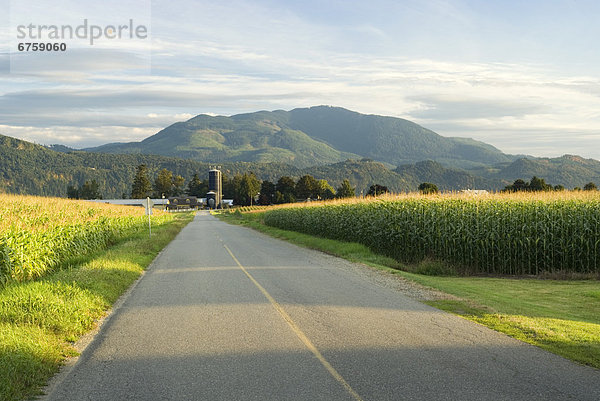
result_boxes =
[220,213,600,368]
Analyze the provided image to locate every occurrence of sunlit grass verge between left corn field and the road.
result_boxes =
[0,213,193,401]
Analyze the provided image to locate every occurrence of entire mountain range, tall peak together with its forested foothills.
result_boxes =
[0,106,600,197]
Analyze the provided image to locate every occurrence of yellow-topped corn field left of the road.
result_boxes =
[0,194,171,283]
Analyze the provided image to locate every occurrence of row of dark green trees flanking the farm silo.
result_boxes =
[126,164,388,206]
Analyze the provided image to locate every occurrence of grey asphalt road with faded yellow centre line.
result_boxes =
[45,214,600,401]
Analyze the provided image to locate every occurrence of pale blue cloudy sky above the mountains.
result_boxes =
[0,0,600,159]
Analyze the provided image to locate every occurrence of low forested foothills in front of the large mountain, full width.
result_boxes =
[0,135,600,198]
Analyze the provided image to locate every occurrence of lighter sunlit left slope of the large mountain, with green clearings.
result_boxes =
[86,112,359,167]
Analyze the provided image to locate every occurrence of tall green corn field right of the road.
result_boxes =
[264,193,600,275]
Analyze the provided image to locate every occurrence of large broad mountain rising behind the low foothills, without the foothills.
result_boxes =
[84,106,516,168]
